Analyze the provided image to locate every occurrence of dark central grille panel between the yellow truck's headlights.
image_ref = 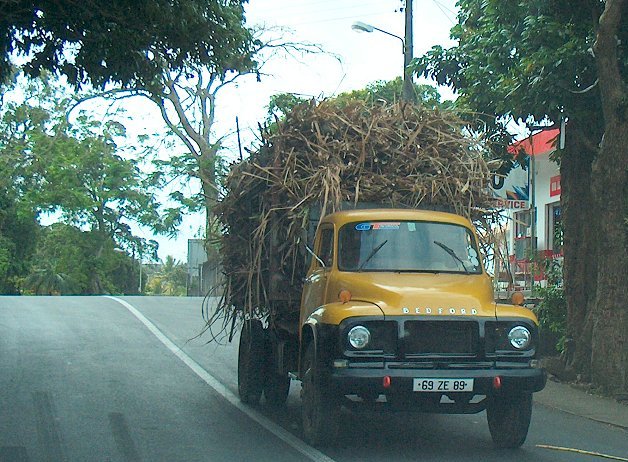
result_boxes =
[404,321,479,357]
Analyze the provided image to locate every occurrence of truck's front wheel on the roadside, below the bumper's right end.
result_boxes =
[486,393,532,449]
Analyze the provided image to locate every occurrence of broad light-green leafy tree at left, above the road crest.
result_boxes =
[0,76,173,293]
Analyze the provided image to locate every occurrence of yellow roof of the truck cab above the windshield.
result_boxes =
[321,209,472,228]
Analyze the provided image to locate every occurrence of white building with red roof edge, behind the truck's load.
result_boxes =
[493,128,563,291]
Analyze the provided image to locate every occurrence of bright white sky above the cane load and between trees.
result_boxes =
[129,0,456,262]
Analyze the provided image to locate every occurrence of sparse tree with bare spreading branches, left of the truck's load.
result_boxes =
[87,26,320,229]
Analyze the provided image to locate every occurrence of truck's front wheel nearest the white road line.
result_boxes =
[301,342,339,446]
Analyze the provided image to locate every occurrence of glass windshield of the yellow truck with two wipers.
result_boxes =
[338,221,482,274]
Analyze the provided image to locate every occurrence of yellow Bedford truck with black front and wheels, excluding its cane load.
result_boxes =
[238,209,546,448]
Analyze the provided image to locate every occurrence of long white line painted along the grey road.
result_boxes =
[105,295,334,462]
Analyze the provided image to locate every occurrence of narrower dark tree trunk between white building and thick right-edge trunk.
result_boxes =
[560,121,599,380]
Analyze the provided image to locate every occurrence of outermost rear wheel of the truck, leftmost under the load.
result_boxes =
[238,319,266,404]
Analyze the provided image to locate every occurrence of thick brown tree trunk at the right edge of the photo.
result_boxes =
[591,0,628,393]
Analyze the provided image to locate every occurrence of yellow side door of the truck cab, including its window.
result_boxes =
[301,225,334,319]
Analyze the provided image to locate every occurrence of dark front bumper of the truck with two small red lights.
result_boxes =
[330,362,547,396]
